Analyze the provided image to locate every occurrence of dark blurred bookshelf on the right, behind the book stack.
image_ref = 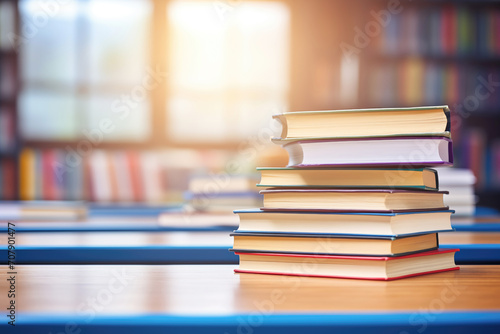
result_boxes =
[359,1,500,209]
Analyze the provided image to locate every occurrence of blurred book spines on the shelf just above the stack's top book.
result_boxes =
[367,58,500,107]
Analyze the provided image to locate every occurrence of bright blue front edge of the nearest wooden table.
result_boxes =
[0,309,500,334]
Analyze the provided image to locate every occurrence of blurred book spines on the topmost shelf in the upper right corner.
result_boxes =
[378,6,500,57]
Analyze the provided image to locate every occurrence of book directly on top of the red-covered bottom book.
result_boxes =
[231,231,438,256]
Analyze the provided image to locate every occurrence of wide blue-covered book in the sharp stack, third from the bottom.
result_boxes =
[234,209,453,236]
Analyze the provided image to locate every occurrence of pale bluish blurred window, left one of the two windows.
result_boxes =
[19,0,153,141]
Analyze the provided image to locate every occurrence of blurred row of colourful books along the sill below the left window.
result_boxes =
[16,148,192,202]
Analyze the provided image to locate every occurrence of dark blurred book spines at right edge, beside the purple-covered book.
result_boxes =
[454,129,500,190]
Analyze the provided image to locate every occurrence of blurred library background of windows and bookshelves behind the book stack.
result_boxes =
[0,0,500,209]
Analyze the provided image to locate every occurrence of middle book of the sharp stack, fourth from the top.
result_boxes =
[260,188,447,212]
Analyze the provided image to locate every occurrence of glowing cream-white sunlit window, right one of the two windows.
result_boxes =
[167,1,289,142]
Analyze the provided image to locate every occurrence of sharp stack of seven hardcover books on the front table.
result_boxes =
[232,106,458,280]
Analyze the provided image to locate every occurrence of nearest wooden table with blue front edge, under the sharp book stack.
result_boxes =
[0,265,500,334]
